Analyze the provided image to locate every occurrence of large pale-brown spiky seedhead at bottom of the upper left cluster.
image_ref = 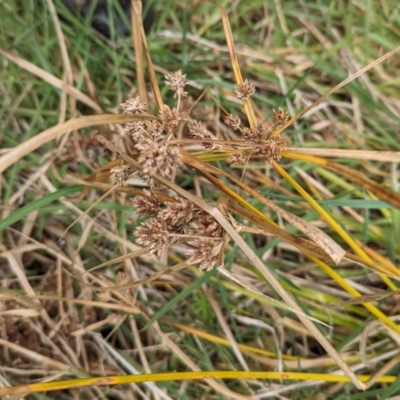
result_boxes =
[135,139,181,178]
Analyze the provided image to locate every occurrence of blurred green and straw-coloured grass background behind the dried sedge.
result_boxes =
[0,0,400,399]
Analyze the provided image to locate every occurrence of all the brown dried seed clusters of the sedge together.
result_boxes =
[115,71,289,270]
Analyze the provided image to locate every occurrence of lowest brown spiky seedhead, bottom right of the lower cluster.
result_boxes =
[187,239,223,271]
